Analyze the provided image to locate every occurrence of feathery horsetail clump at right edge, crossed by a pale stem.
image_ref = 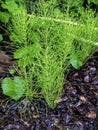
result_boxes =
[71,9,98,68]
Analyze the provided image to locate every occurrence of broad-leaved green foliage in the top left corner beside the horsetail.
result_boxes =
[0,0,24,46]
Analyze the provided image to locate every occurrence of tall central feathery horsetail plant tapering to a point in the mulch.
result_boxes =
[33,20,73,108]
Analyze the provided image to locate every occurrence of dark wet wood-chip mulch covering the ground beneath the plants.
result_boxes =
[0,52,98,130]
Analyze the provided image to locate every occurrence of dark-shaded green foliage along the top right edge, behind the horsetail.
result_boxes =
[57,0,98,16]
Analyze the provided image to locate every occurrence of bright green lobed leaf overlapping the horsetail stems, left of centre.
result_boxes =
[14,43,41,66]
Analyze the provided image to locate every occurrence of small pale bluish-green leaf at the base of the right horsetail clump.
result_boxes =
[70,55,83,69]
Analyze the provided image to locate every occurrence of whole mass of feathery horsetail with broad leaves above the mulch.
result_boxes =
[2,1,98,108]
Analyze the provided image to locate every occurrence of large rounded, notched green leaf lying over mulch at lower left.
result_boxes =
[2,76,25,100]
